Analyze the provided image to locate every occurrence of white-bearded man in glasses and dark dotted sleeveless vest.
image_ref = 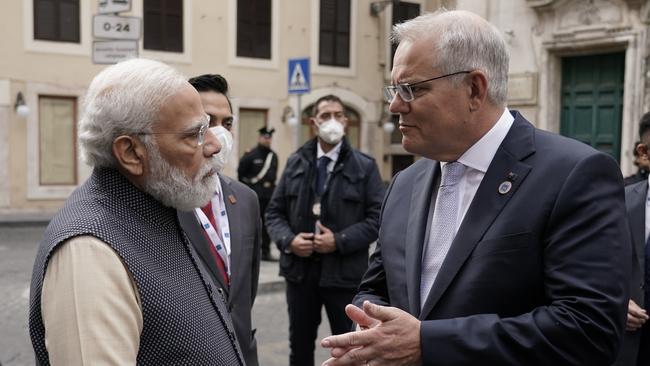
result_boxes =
[29,59,244,366]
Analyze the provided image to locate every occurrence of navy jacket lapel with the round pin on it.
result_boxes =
[420,114,535,319]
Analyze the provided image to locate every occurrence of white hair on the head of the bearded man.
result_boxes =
[79,59,187,167]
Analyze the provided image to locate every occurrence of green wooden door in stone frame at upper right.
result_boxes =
[560,52,625,161]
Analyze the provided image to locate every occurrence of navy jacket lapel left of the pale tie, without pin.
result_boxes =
[404,161,440,316]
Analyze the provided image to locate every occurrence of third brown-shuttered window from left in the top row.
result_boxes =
[237,0,272,59]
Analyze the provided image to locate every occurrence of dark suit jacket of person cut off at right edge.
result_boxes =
[616,179,650,366]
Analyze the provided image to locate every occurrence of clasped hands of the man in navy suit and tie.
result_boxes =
[321,301,422,366]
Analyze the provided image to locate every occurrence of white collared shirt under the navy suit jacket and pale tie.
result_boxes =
[440,108,515,231]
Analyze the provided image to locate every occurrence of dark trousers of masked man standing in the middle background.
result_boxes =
[287,261,357,366]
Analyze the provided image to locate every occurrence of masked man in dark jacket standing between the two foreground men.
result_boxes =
[266,95,384,366]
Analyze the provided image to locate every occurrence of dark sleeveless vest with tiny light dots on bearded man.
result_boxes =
[29,169,244,366]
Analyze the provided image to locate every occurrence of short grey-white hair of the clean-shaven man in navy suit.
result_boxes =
[391,9,510,106]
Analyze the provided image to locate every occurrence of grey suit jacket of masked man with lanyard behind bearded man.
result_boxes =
[178,175,261,366]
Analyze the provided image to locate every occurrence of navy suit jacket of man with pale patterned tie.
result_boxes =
[354,112,632,366]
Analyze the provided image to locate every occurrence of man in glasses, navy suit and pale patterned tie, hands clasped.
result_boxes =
[321,11,632,366]
